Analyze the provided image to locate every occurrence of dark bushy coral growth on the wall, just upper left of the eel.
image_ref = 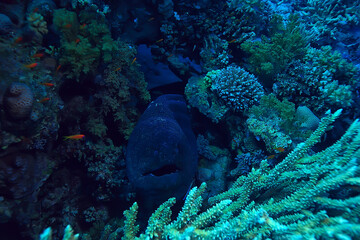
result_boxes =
[88,41,150,139]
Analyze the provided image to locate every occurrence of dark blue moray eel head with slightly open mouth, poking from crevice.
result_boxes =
[126,94,197,210]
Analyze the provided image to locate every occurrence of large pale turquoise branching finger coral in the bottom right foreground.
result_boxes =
[118,111,360,239]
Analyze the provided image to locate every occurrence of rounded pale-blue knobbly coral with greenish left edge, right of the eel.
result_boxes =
[185,66,264,122]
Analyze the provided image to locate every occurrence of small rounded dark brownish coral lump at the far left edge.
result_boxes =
[3,82,34,120]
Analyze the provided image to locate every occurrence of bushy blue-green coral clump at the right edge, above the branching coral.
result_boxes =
[273,47,359,113]
